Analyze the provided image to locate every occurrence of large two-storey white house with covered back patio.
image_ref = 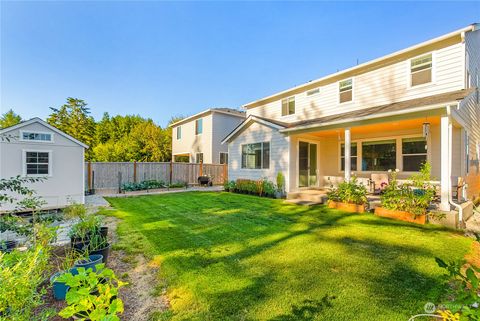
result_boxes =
[223,24,480,218]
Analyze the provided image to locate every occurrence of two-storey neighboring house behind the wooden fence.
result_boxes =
[170,108,245,164]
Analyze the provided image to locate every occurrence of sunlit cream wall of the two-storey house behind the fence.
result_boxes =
[172,114,212,163]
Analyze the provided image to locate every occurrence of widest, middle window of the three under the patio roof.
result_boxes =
[362,139,397,171]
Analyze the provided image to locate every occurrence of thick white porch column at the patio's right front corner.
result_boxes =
[440,116,450,211]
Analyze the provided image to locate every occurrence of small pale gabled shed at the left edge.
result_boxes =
[0,118,88,211]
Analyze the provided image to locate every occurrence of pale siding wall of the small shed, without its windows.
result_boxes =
[0,123,85,210]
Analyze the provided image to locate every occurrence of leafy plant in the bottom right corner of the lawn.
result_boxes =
[435,234,480,321]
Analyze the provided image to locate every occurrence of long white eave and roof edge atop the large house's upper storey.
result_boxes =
[246,23,480,109]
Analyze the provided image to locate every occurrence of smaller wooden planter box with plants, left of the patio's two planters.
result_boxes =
[327,176,367,213]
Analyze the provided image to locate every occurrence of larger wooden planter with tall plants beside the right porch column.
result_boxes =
[375,162,435,224]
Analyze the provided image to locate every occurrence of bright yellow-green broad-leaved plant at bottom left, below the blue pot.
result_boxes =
[58,264,127,321]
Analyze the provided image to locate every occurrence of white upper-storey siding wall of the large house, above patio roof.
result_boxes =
[247,41,464,122]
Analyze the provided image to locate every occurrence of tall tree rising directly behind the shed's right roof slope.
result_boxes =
[47,97,95,160]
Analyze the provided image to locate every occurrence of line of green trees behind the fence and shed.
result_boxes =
[0,97,182,162]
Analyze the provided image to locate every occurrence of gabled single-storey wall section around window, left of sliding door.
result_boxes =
[228,122,290,191]
